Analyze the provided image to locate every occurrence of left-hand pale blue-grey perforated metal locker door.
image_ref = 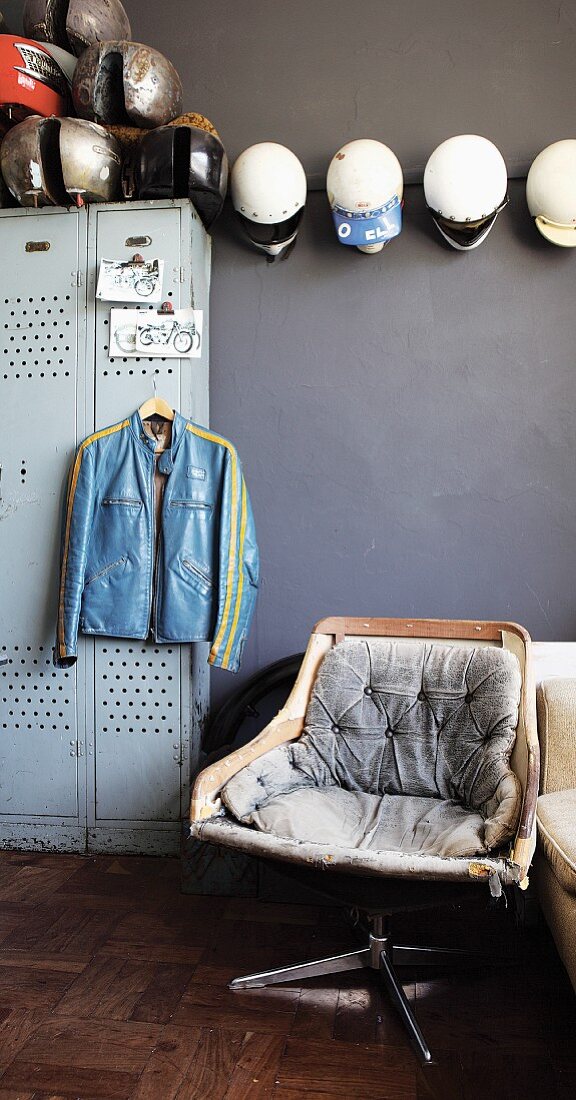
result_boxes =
[0,210,87,850]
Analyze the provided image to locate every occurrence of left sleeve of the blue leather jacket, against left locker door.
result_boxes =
[54,442,95,669]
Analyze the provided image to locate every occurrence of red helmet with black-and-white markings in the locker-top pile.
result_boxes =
[0,34,75,122]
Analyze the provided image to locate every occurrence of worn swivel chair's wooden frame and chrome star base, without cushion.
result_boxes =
[190,618,539,1064]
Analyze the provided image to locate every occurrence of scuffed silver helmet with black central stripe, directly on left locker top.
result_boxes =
[0,114,122,207]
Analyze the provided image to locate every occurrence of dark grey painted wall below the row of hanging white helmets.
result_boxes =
[205,180,576,690]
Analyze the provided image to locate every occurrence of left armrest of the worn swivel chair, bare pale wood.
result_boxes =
[190,710,304,822]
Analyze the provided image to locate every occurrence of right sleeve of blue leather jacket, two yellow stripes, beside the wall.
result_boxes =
[209,448,259,672]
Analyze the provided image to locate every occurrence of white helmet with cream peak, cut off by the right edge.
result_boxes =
[527,139,576,249]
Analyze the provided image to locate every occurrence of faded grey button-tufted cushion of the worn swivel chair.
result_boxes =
[222,639,521,856]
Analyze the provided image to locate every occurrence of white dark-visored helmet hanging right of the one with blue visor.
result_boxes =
[424,134,508,251]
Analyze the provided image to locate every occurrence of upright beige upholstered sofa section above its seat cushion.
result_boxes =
[536,679,576,794]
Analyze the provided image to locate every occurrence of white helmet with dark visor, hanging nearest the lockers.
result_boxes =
[231,141,306,256]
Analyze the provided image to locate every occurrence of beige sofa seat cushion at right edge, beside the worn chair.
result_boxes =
[536,790,576,894]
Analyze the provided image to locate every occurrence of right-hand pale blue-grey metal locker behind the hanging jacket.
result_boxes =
[87,201,210,854]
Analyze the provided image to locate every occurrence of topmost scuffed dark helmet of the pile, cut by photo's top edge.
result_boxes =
[22,0,132,56]
